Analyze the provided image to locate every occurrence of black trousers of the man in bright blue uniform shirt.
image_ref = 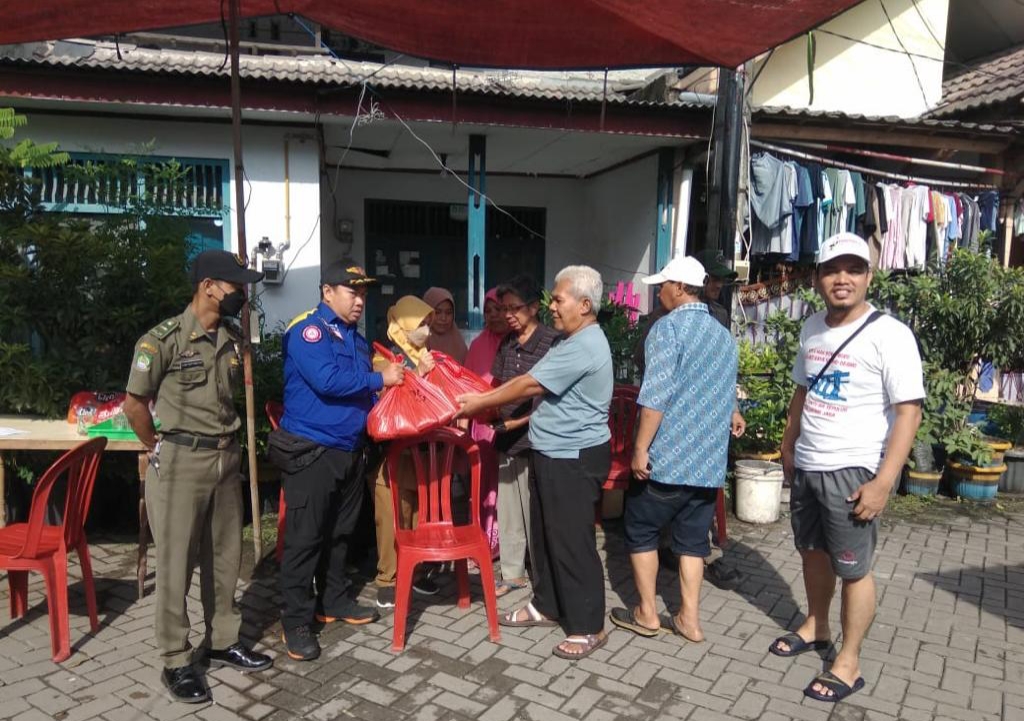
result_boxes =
[281,449,366,630]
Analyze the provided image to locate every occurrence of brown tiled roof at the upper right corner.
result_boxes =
[928,45,1024,118]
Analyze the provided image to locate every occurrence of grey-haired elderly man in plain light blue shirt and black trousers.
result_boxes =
[459,265,610,661]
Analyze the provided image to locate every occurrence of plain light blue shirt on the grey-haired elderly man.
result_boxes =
[529,324,614,458]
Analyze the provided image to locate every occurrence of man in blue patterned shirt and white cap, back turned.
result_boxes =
[611,257,737,641]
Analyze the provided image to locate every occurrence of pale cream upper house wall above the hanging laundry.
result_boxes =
[752,0,949,118]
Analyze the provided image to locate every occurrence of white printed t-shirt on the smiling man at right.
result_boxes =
[793,308,925,473]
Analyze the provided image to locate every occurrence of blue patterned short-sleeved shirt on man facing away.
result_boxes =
[637,303,737,489]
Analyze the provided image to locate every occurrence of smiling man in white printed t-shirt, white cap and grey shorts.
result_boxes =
[769,232,925,702]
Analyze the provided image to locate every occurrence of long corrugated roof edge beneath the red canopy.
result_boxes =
[0,40,714,108]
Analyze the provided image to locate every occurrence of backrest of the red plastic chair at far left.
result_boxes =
[14,437,106,558]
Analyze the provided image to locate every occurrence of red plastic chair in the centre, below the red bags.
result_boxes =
[387,428,501,651]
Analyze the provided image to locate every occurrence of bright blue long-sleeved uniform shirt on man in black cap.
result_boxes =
[281,303,384,451]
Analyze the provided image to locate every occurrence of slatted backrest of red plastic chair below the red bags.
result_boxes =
[387,428,480,528]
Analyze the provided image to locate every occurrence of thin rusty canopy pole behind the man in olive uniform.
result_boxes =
[227,0,263,563]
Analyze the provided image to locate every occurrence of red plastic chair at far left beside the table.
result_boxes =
[0,438,106,663]
